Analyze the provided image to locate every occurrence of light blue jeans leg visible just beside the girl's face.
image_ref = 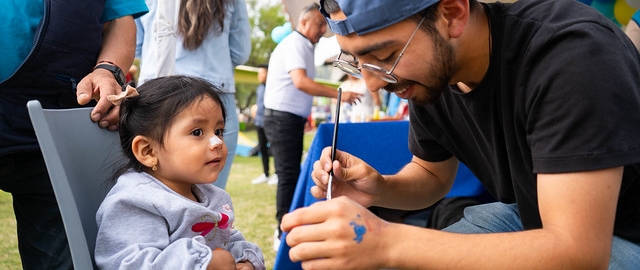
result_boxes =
[213,93,240,189]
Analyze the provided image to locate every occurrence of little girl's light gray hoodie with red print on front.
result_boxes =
[95,171,265,270]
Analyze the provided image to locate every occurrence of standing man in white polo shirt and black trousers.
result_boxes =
[264,4,360,251]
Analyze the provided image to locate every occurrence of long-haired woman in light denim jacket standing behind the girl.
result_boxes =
[136,0,251,189]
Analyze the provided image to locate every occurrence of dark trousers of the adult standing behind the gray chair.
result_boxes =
[0,152,73,269]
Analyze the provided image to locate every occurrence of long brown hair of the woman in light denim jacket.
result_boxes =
[178,0,233,50]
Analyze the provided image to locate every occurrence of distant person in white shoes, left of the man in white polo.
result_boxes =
[251,65,278,185]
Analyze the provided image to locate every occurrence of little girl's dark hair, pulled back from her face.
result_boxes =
[112,76,226,180]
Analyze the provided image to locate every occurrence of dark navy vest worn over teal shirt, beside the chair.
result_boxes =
[0,0,104,156]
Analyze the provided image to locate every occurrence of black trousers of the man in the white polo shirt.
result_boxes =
[264,110,307,235]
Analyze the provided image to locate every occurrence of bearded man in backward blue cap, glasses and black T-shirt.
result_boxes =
[282,0,640,269]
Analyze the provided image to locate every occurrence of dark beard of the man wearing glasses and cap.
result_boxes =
[385,30,455,105]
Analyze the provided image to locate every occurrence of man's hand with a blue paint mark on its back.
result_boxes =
[281,197,392,269]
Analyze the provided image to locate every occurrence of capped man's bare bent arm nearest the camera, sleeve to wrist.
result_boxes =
[387,168,623,269]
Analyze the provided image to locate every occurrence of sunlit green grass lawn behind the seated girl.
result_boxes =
[0,127,315,270]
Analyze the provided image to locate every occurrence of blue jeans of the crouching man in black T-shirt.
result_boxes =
[443,202,640,269]
